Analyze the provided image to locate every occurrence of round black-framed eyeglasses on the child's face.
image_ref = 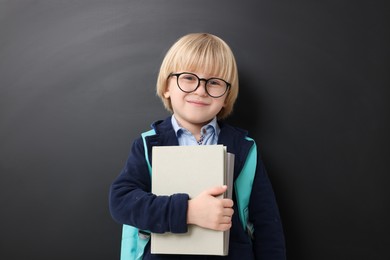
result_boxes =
[169,72,230,98]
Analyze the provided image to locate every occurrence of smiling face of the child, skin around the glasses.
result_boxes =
[164,71,227,133]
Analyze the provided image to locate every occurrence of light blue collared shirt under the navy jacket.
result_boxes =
[171,115,221,145]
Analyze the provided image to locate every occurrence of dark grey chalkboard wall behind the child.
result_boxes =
[0,0,390,260]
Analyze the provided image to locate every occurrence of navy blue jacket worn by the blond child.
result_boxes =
[109,117,286,260]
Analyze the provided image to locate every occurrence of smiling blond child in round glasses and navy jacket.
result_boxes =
[110,33,286,260]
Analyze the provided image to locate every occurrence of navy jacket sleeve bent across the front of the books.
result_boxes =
[109,138,189,233]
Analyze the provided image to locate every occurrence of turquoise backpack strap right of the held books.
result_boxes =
[234,137,257,238]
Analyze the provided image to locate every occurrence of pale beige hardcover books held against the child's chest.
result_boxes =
[151,145,234,255]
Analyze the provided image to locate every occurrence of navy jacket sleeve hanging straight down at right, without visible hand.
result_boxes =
[249,156,286,260]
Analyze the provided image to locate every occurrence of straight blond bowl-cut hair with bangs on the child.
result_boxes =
[157,33,238,119]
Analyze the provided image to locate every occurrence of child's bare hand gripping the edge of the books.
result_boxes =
[187,186,234,231]
